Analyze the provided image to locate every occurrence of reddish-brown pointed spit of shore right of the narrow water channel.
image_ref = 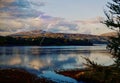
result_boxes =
[55,68,95,83]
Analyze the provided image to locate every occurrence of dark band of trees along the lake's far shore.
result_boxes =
[0,36,93,46]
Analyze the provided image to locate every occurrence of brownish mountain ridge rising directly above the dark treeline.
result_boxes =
[9,30,98,38]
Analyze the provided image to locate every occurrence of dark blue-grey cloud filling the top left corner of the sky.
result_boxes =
[0,0,45,18]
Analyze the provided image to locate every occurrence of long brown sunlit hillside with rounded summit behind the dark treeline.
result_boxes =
[9,30,100,39]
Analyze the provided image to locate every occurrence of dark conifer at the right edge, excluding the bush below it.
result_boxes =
[103,0,120,67]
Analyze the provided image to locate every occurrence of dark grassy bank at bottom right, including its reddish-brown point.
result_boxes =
[57,66,120,83]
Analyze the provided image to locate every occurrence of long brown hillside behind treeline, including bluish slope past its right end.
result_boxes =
[9,30,108,44]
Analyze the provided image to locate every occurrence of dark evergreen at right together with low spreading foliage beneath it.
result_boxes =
[81,0,120,83]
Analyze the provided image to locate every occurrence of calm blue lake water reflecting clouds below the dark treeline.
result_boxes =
[0,45,113,71]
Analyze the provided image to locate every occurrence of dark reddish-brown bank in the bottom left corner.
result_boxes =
[0,69,54,83]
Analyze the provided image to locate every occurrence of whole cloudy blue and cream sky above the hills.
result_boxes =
[0,0,111,35]
